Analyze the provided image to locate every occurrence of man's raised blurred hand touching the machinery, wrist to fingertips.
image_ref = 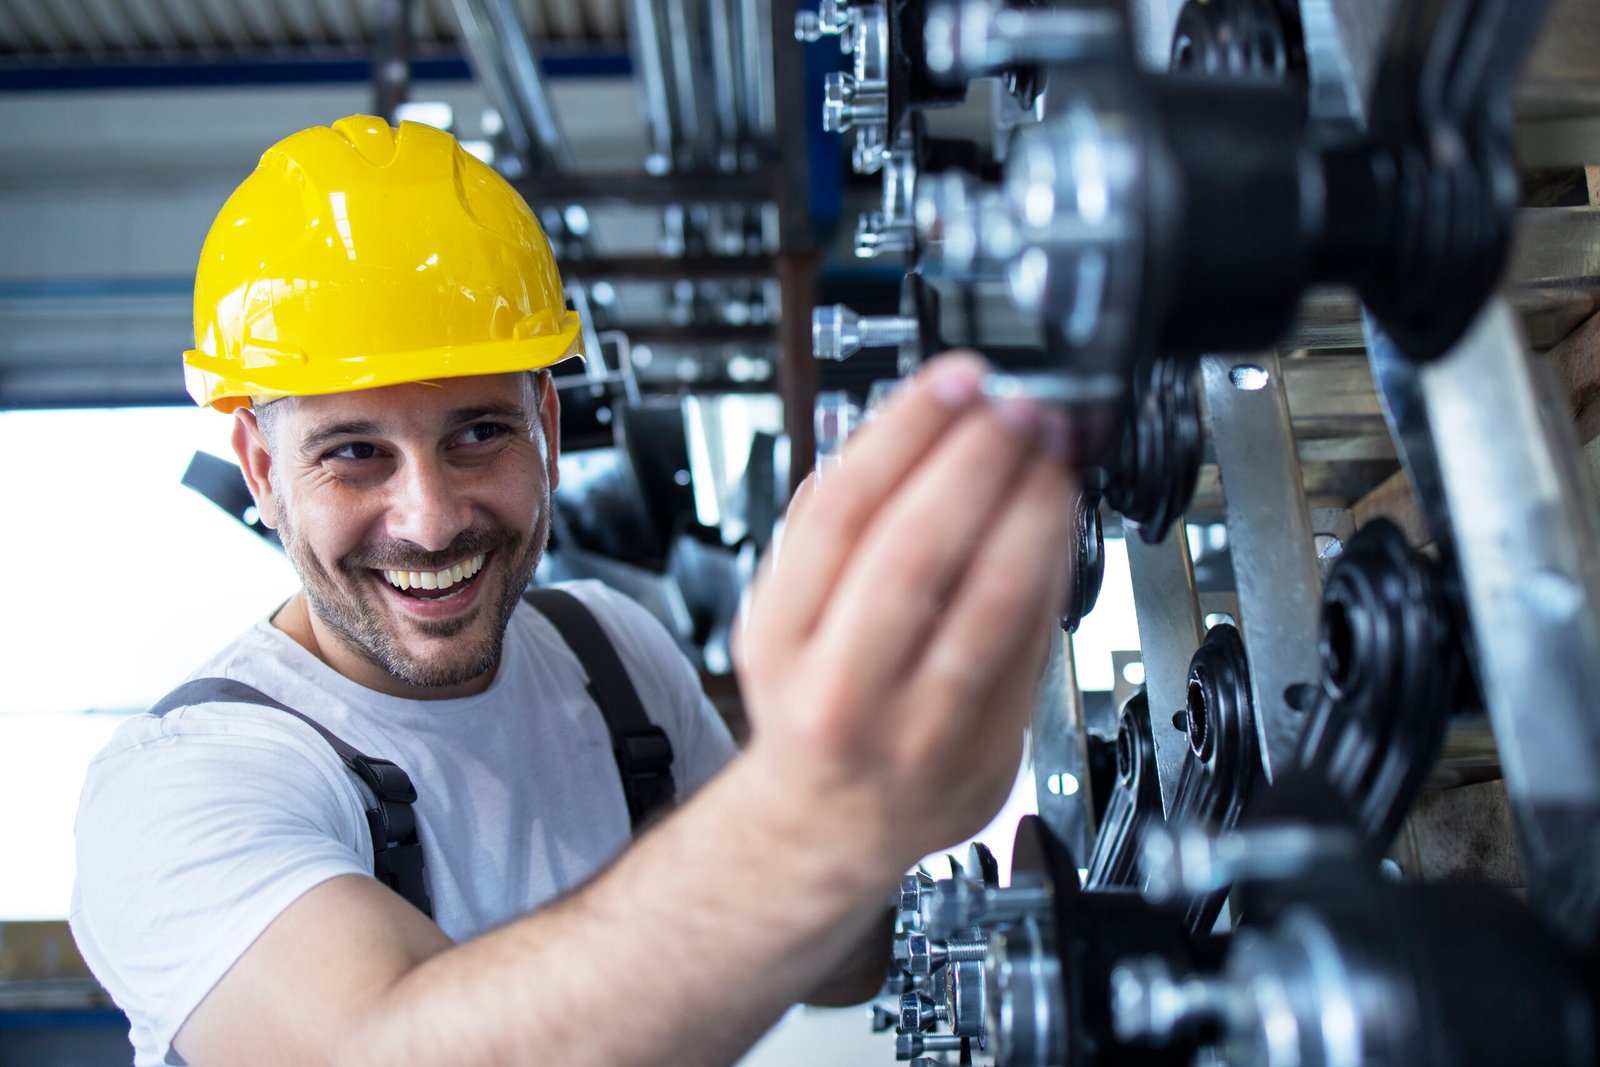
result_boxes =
[738,355,1072,880]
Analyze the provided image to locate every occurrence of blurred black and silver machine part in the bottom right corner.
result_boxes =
[1109,830,1597,1067]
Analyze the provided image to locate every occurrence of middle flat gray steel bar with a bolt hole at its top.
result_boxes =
[1200,352,1322,781]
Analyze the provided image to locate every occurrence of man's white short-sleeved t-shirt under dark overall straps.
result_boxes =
[70,582,734,1067]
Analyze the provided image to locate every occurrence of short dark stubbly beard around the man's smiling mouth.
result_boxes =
[278,490,550,688]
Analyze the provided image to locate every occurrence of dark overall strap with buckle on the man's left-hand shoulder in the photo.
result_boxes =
[150,678,434,918]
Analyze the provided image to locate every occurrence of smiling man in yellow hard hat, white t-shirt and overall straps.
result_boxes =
[72,117,1072,1065]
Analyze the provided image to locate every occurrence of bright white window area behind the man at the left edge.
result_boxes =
[0,408,298,920]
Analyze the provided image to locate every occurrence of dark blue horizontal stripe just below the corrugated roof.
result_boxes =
[0,51,634,93]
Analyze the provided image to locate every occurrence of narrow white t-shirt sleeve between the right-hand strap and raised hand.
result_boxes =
[573,582,738,797]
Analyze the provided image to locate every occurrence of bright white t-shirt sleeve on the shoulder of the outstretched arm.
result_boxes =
[72,709,371,1062]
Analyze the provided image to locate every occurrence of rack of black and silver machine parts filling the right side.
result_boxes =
[797,0,1600,1067]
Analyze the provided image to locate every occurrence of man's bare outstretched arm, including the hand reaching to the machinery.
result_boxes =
[178,358,1072,1067]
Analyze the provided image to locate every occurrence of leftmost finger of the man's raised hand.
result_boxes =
[752,355,987,643]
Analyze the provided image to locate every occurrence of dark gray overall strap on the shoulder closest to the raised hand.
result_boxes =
[523,589,677,833]
